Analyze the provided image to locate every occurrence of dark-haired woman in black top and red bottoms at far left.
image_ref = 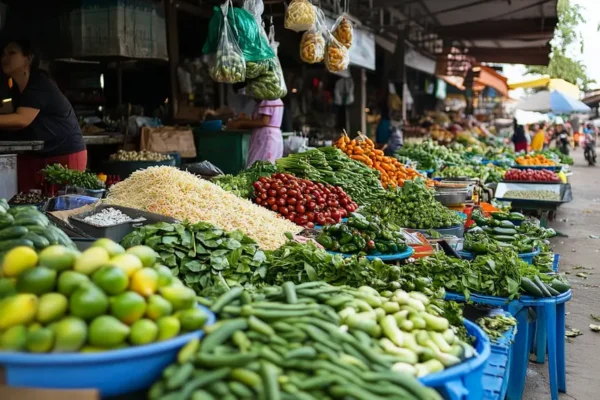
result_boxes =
[0,41,87,192]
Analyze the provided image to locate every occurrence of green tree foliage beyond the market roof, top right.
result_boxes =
[527,0,595,89]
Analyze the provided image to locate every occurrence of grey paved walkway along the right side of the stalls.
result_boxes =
[523,150,600,400]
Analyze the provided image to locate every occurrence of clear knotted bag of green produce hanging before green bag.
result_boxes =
[208,1,246,83]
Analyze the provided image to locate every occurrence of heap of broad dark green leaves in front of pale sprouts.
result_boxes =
[121,222,267,295]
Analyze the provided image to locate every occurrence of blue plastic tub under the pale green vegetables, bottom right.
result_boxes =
[419,320,491,400]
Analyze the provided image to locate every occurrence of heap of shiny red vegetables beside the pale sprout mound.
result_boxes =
[254,173,358,228]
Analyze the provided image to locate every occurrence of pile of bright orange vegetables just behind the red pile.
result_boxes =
[335,133,433,188]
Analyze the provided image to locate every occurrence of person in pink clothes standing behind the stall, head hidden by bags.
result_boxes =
[227,99,283,167]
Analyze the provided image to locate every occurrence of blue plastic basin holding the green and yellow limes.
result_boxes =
[0,306,215,397]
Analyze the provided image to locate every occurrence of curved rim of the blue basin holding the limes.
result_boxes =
[0,305,216,368]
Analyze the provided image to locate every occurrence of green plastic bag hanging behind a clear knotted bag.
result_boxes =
[202,2,275,62]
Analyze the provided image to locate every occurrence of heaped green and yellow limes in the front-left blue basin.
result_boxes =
[0,239,208,353]
